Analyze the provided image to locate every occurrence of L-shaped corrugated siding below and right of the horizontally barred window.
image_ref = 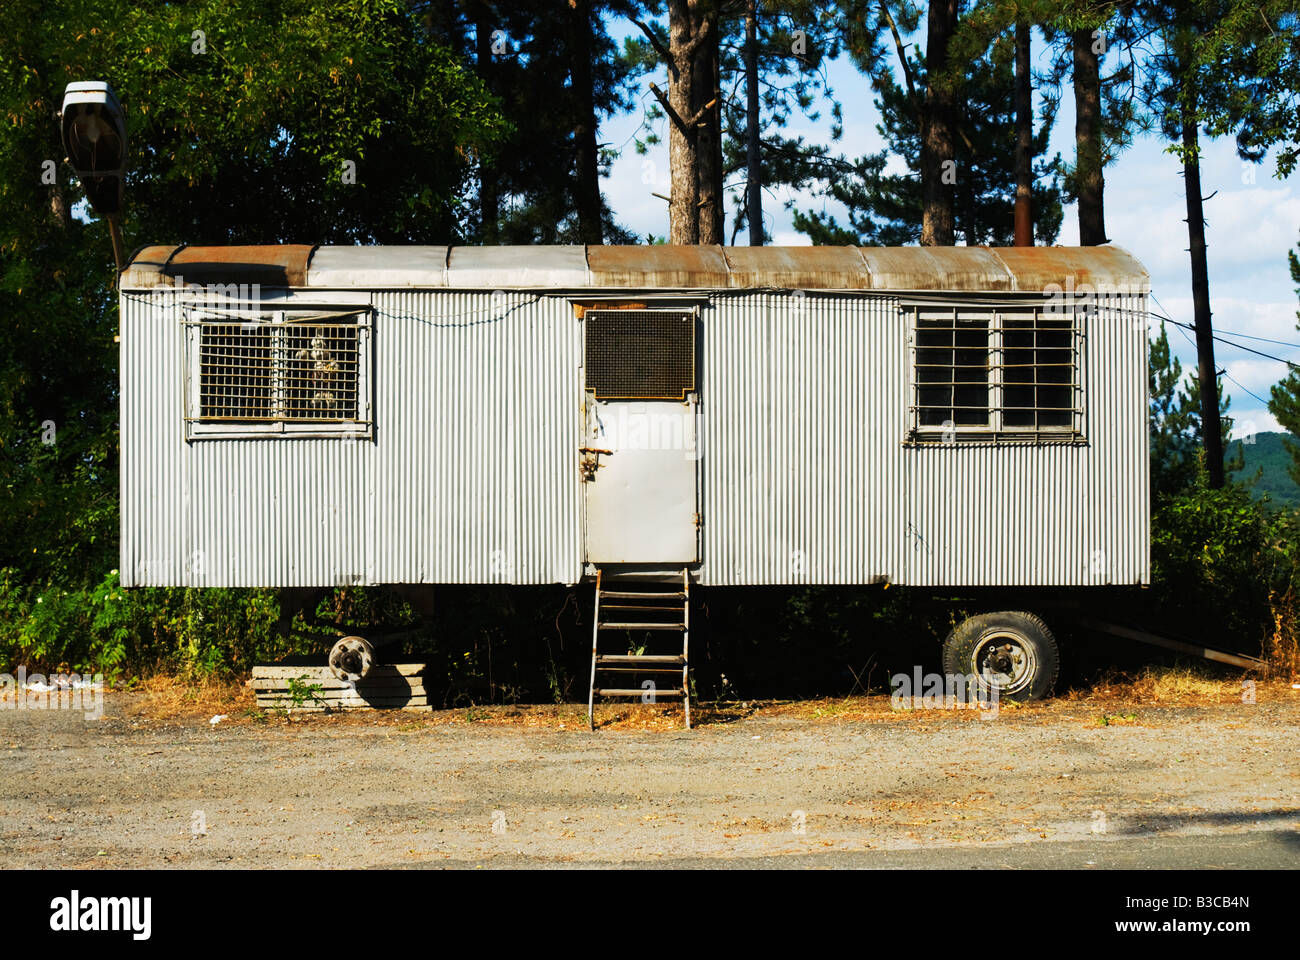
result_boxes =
[904,297,1151,587]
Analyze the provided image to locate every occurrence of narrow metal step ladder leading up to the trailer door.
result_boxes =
[586,568,690,730]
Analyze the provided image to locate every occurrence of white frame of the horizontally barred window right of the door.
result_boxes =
[901,298,1092,445]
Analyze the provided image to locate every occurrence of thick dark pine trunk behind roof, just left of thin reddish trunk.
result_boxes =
[920,0,958,247]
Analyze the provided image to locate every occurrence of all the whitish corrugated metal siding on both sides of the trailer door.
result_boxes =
[121,283,1149,587]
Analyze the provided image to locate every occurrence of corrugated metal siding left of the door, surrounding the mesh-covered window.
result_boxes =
[122,286,581,587]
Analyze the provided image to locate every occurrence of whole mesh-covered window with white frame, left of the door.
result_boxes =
[189,312,369,436]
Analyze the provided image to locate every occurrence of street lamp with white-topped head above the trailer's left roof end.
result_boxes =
[60,81,126,272]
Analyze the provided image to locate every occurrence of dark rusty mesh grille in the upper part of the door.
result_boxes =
[584,310,696,401]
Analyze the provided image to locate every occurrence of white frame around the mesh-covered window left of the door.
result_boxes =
[183,303,374,441]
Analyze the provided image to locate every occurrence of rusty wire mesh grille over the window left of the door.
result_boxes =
[199,323,359,423]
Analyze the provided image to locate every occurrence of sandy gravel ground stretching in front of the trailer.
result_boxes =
[0,692,1300,868]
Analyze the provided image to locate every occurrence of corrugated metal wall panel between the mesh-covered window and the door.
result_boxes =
[371,293,582,583]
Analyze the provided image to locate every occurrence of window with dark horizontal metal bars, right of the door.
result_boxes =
[911,307,1083,440]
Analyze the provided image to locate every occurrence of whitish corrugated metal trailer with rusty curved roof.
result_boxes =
[120,246,1149,712]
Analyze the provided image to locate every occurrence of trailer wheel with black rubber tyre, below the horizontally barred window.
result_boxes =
[944,611,1061,700]
